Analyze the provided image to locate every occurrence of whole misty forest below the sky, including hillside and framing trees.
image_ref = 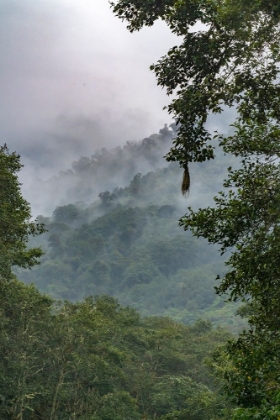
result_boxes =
[0,0,280,420]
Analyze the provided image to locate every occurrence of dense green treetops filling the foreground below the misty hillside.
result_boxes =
[0,281,233,420]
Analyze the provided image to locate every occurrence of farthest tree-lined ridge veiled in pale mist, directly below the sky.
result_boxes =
[27,124,176,215]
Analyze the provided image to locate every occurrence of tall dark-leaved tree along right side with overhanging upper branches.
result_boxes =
[112,0,280,419]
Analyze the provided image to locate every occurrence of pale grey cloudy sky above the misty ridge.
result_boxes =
[0,0,177,178]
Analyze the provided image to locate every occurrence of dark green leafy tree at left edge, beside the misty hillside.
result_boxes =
[0,145,44,279]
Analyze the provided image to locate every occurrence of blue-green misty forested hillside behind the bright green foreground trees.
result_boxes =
[18,124,243,331]
